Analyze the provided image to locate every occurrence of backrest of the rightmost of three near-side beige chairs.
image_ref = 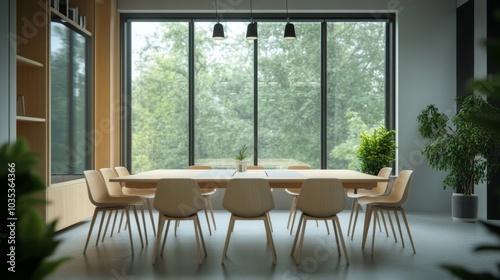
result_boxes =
[297,178,346,217]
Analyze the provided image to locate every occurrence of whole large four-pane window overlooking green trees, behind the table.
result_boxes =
[123,15,394,172]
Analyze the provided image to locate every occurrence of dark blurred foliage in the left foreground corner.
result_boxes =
[0,140,68,279]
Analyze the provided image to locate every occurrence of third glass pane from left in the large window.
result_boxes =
[258,22,321,168]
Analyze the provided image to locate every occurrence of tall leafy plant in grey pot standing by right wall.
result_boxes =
[417,94,500,222]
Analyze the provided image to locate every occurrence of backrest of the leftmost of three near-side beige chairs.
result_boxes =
[154,178,205,218]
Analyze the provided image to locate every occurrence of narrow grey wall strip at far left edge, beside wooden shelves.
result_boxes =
[0,0,16,145]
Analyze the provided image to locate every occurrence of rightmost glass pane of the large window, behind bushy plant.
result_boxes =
[327,22,386,169]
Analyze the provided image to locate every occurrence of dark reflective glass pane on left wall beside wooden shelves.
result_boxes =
[50,22,91,183]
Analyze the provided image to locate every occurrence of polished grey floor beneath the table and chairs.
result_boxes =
[49,210,499,280]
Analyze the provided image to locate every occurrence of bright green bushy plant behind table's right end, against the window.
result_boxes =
[356,126,396,175]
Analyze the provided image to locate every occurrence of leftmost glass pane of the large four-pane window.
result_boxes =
[131,22,189,173]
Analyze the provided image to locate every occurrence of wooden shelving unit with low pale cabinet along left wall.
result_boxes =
[16,0,95,229]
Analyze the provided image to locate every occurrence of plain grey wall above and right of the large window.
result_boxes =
[118,0,457,212]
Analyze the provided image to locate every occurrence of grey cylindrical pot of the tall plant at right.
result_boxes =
[451,193,478,223]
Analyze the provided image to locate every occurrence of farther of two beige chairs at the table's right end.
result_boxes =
[346,167,394,240]
